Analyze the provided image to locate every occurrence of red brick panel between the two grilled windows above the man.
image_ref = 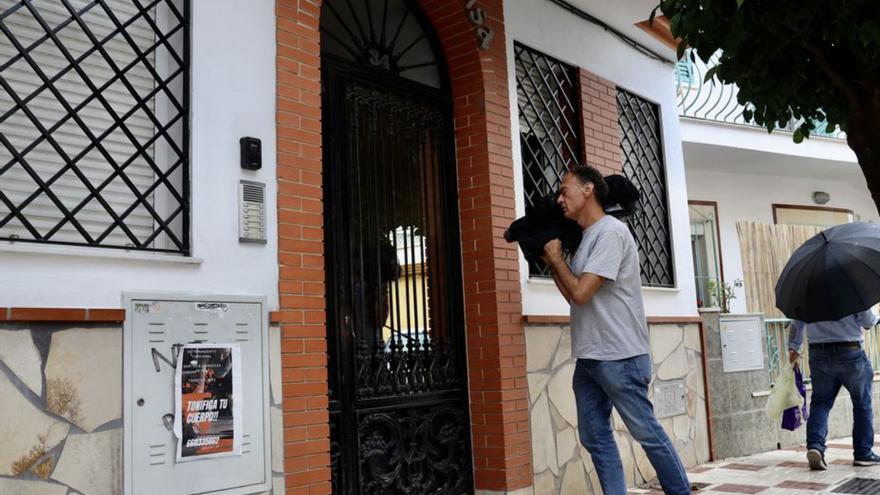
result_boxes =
[578,69,623,175]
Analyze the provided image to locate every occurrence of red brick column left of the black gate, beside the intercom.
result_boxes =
[276,0,331,495]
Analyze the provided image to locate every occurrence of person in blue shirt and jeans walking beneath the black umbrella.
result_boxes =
[788,309,880,471]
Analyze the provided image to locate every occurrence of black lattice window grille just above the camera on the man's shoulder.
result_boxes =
[514,43,582,276]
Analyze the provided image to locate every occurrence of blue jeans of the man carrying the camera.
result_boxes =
[573,354,691,495]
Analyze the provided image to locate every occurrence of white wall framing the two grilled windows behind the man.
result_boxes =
[504,0,697,316]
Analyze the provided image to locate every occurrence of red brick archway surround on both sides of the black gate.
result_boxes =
[276,0,532,495]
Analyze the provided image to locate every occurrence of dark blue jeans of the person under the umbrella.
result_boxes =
[807,349,874,459]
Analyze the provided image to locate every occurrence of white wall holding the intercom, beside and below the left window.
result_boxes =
[0,0,278,309]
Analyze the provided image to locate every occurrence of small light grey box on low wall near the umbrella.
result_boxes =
[721,314,764,372]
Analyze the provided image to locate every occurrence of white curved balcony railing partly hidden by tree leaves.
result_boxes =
[675,50,846,139]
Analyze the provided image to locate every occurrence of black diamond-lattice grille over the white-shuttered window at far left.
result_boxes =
[0,0,189,254]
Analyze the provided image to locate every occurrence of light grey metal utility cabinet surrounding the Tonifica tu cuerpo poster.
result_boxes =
[123,294,272,495]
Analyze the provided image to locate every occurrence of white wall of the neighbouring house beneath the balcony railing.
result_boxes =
[685,153,880,313]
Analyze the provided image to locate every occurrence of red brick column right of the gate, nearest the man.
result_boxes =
[421,0,532,491]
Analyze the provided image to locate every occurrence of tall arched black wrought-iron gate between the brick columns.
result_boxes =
[321,0,473,494]
